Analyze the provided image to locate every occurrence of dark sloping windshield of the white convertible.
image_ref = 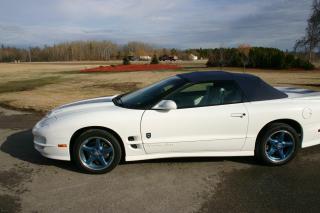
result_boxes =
[113,76,185,109]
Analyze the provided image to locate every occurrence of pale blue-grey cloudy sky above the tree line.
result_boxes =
[0,0,312,50]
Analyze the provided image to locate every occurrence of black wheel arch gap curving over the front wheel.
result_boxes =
[69,126,126,161]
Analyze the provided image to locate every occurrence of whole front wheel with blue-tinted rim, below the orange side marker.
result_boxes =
[73,129,121,174]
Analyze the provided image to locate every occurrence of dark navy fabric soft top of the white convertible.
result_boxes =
[177,71,288,101]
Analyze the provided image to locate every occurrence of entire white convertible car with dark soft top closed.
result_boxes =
[33,71,320,173]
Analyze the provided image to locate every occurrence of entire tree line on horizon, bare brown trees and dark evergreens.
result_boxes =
[0,41,314,69]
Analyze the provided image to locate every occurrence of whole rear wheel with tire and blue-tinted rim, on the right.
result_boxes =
[255,123,300,165]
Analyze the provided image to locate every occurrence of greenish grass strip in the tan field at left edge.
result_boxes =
[0,76,62,93]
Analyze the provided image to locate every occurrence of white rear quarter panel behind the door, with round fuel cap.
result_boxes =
[243,98,320,150]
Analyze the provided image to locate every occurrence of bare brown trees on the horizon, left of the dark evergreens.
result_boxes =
[0,41,188,62]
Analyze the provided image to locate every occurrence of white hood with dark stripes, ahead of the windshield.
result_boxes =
[46,96,116,117]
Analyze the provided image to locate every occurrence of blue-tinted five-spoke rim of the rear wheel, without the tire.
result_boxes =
[265,130,296,163]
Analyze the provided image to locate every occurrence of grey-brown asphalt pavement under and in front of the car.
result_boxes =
[0,108,320,213]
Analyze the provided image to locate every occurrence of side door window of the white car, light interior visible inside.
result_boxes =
[166,81,242,109]
